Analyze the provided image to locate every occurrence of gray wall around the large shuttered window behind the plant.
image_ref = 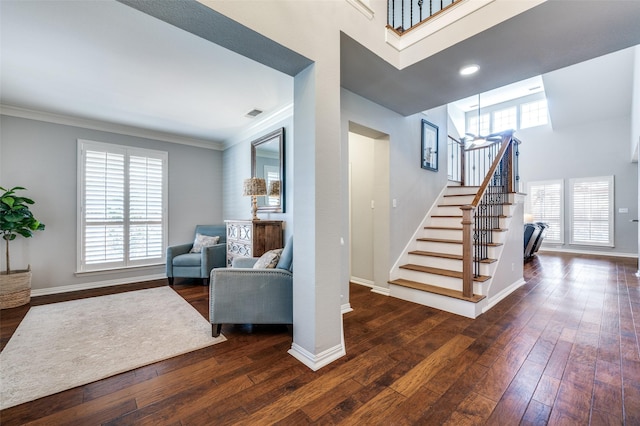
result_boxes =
[0,116,222,290]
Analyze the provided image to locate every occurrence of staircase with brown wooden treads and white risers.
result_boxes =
[389,186,512,318]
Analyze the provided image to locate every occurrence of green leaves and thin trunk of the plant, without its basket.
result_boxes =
[0,186,44,275]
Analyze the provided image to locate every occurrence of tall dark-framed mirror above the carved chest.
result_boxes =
[251,127,285,213]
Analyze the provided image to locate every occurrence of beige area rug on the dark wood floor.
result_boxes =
[0,287,226,409]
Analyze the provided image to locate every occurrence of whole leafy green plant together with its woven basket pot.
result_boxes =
[0,186,44,309]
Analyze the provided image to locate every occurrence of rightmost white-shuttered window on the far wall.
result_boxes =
[569,176,614,247]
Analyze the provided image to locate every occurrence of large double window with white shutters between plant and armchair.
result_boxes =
[78,140,167,272]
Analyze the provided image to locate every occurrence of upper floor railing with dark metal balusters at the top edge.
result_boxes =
[387,0,463,34]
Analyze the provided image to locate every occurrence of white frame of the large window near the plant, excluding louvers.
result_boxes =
[76,139,168,273]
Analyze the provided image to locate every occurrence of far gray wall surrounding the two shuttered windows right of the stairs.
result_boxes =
[516,117,638,254]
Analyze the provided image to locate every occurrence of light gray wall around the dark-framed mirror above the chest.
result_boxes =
[222,116,294,241]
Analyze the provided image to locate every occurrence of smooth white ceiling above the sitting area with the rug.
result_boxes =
[0,1,293,142]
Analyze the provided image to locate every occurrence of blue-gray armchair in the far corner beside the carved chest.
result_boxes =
[167,225,227,285]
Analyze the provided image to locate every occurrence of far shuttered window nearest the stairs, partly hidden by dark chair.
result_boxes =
[527,180,564,244]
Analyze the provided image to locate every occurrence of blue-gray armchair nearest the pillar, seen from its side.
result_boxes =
[209,238,293,337]
